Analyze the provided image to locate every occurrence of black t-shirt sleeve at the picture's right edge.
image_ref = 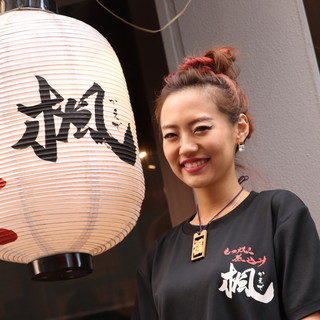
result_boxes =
[274,193,320,320]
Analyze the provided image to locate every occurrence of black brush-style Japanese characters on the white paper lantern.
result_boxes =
[12,76,136,165]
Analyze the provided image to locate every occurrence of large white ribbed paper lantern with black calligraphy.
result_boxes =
[0,0,144,280]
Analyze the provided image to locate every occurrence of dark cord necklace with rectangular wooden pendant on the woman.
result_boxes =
[191,187,244,261]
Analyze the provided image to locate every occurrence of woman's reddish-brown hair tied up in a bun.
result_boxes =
[155,47,254,138]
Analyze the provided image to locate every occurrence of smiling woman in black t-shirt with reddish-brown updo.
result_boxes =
[132,47,320,320]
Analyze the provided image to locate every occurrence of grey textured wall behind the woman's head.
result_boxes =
[156,0,320,230]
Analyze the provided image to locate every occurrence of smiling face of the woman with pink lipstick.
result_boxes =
[160,88,243,188]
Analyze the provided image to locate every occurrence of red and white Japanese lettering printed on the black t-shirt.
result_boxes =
[219,246,274,303]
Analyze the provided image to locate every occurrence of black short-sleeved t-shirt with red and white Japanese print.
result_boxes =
[132,190,320,320]
